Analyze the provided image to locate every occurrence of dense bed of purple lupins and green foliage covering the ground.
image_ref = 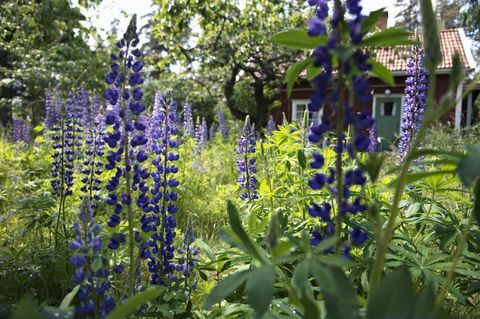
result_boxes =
[0,0,480,319]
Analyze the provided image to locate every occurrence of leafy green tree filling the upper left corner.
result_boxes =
[0,0,108,126]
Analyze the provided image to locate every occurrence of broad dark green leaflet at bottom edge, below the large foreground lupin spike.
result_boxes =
[312,264,359,319]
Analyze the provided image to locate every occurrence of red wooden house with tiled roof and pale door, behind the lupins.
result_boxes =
[272,25,479,141]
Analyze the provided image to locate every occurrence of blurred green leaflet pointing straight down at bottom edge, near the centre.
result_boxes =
[246,265,275,318]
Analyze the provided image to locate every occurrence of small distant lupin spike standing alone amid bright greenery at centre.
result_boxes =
[237,115,258,201]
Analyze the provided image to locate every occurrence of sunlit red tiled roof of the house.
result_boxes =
[374,29,475,72]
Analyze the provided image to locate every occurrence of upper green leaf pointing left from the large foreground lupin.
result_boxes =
[272,29,327,49]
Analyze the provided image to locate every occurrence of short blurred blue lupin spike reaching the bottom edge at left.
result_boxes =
[70,199,115,318]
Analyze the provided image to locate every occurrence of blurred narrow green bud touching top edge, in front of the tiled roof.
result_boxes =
[420,0,442,71]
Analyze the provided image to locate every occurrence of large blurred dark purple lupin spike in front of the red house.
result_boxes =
[308,0,374,256]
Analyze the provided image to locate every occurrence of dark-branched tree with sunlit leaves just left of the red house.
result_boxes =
[153,0,305,127]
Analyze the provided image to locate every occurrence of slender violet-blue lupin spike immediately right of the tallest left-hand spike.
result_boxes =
[139,94,183,286]
